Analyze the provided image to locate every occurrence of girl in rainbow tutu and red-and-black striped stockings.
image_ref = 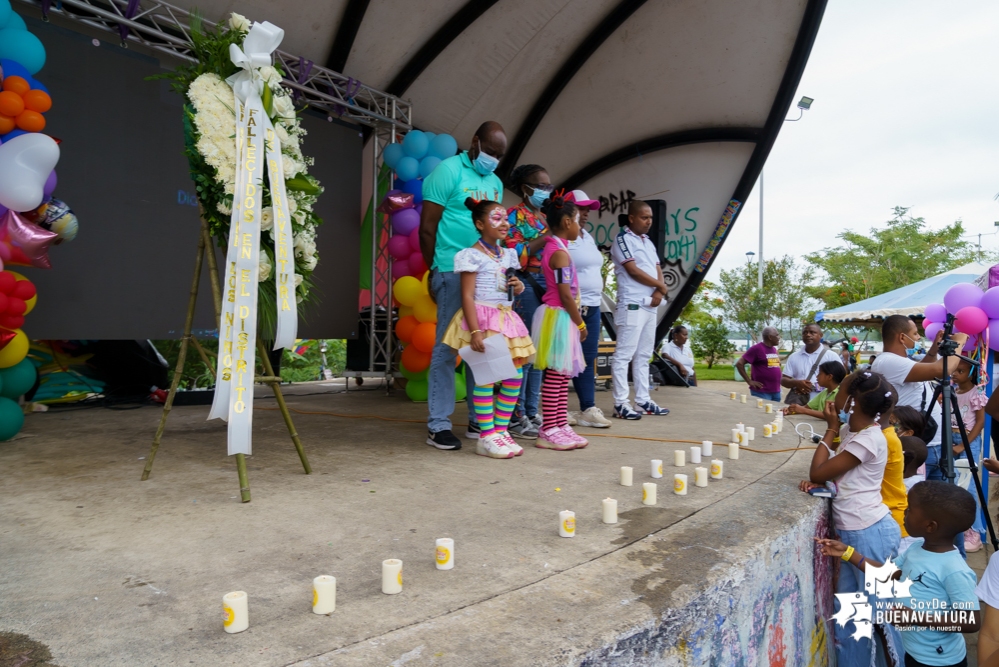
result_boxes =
[531,192,596,450]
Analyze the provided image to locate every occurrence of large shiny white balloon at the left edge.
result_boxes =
[0,132,59,212]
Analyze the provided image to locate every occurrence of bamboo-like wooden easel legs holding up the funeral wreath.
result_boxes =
[142,216,312,503]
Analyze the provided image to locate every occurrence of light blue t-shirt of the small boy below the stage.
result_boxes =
[895,540,978,665]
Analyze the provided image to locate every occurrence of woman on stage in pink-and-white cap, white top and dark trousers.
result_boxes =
[568,190,611,428]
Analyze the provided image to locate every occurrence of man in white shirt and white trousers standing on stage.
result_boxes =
[611,201,669,419]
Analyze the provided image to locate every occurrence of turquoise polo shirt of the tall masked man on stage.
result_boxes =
[423,151,503,271]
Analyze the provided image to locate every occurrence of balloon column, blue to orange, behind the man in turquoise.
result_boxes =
[379,130,465,401]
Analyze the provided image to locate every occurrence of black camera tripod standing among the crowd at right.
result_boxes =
[925,314,999,552]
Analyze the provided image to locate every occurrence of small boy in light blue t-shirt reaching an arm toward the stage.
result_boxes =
[815,481,981,667]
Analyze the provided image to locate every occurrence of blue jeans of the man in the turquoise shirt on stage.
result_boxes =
[427,269,475,433]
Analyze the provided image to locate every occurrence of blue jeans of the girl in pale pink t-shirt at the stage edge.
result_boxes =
[833,516,904,667]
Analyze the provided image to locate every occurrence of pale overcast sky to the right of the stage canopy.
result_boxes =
[708,0,999,281]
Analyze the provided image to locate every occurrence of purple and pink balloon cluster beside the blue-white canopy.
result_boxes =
[923,283,999,352]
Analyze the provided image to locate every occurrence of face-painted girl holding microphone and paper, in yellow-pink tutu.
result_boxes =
[442,197,534,459]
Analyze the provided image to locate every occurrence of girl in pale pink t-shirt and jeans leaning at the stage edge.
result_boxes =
[799,371,902,667]
